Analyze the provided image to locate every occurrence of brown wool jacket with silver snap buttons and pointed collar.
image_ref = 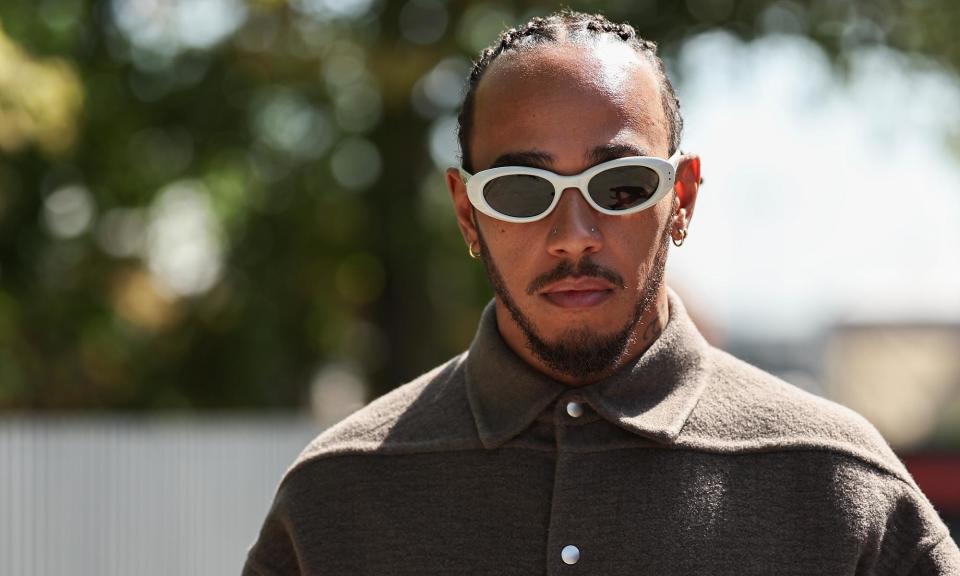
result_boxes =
[243,293,960,576]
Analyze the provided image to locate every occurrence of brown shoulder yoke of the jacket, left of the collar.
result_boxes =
[290,352,480,470]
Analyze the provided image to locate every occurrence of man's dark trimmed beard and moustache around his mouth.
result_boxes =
[474,214,670,380]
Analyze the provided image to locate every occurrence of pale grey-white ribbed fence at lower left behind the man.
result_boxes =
[0,415,320,576]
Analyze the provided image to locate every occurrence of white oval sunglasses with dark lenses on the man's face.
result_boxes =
[460,150,680,222]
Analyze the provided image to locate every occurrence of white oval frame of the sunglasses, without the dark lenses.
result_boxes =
[460,149,680,223]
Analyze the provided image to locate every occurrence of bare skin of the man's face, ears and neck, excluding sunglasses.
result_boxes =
[446,40,700,385]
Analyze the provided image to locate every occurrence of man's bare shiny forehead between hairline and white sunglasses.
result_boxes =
[471,42,667,170]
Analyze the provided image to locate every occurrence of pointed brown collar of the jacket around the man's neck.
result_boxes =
[466,289,709,448]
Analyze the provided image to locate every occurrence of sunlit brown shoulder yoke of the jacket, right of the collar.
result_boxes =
[681,349,913,484]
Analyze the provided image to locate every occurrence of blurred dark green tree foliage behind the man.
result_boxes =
[0,0,960,409]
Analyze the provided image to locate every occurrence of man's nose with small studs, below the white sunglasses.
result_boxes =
[547,188,603,260]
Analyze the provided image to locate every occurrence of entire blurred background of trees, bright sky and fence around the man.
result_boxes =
[0,0,960,575]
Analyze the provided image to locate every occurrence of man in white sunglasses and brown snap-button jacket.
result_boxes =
[244,12,960,575]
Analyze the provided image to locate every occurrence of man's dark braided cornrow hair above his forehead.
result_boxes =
[457,9,683,172]
